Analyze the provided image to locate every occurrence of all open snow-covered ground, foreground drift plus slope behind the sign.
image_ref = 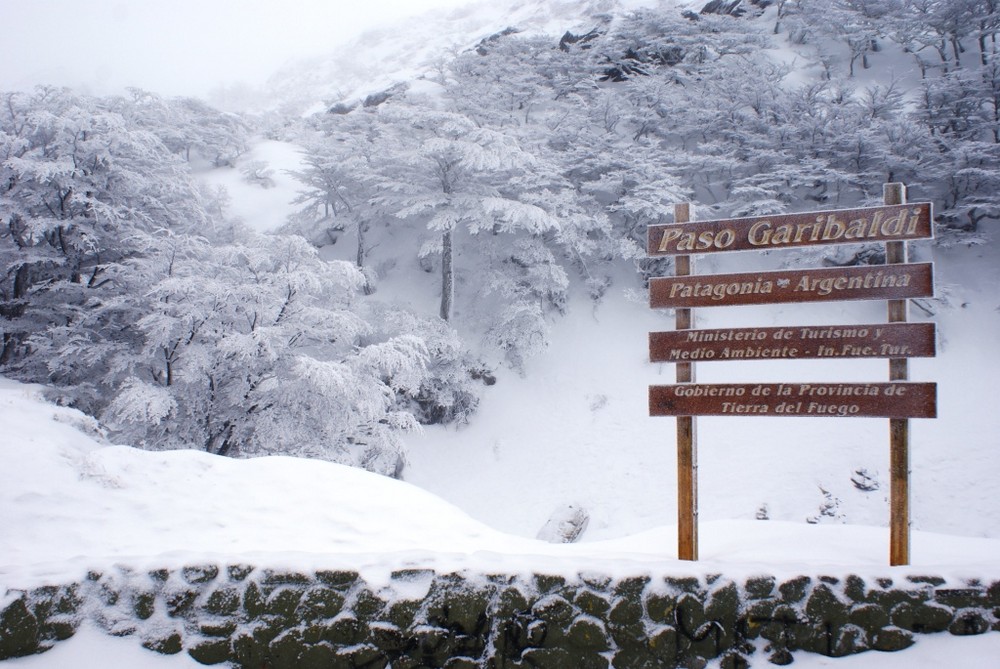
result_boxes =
[0,185,1000,669]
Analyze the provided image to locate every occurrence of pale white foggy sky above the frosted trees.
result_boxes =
[0,0,470,97]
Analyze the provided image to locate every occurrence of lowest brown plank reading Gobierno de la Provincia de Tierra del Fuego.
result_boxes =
[649,381,937,418]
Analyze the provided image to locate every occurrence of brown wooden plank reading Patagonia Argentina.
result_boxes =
[649,263,934,308]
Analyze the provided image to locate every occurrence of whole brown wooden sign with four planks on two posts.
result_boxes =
[647,184,937,565]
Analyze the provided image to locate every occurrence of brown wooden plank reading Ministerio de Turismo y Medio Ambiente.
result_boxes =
[649,323,936,362]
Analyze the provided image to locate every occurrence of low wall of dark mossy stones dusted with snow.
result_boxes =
[0,564,1000,669]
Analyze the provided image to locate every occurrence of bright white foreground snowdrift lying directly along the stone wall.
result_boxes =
[0,360,1000,669]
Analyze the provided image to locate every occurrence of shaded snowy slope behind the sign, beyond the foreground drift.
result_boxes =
[191,142,1000,550]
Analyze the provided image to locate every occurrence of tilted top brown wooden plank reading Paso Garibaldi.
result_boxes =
[646,202,934,256]
